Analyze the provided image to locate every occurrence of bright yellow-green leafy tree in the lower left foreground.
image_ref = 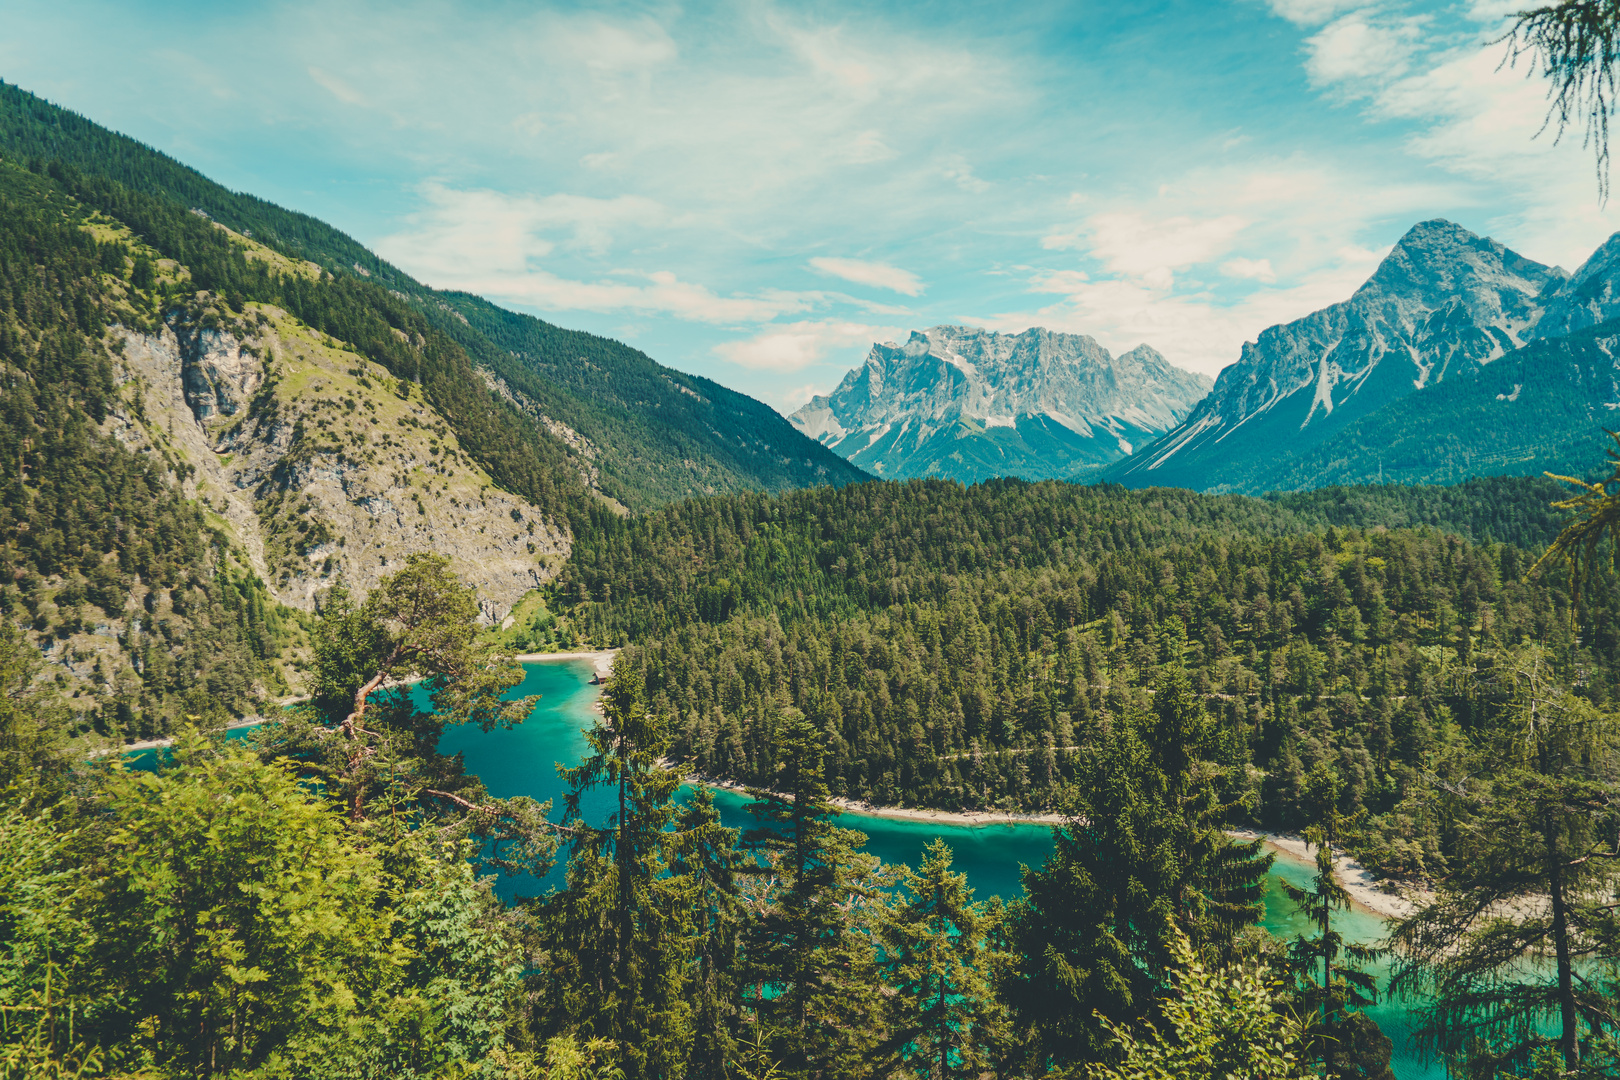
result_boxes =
[86,737,410,1075]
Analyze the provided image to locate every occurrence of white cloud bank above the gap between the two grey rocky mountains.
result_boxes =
[1010,157,1458,374]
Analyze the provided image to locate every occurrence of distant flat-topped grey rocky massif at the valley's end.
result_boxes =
[789,325,1210,483]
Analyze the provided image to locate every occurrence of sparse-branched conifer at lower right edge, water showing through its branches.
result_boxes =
[1393,646,1620,1075]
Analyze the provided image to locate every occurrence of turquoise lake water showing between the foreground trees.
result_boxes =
[441,661,1445,1080]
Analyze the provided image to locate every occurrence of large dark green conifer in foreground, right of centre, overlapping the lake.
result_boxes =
[1003,672,1272,1065]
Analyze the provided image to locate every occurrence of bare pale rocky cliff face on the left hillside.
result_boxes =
[107,304,570,622]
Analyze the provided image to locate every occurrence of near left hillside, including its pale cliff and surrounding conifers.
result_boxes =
[0,152,589,735]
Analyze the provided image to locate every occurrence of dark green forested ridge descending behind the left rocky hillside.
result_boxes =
[0,83,865,508]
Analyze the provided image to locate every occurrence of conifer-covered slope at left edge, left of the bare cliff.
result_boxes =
[0,162,290,738]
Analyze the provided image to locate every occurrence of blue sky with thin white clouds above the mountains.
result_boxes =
[0,0,1620,411]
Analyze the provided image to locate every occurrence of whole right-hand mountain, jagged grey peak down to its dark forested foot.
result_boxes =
[1103,220,1620,494]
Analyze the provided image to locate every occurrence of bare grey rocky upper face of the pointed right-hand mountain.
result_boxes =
[1108,220,1581,492]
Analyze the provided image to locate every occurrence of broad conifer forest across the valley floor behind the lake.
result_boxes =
[559,476,1620,873]
